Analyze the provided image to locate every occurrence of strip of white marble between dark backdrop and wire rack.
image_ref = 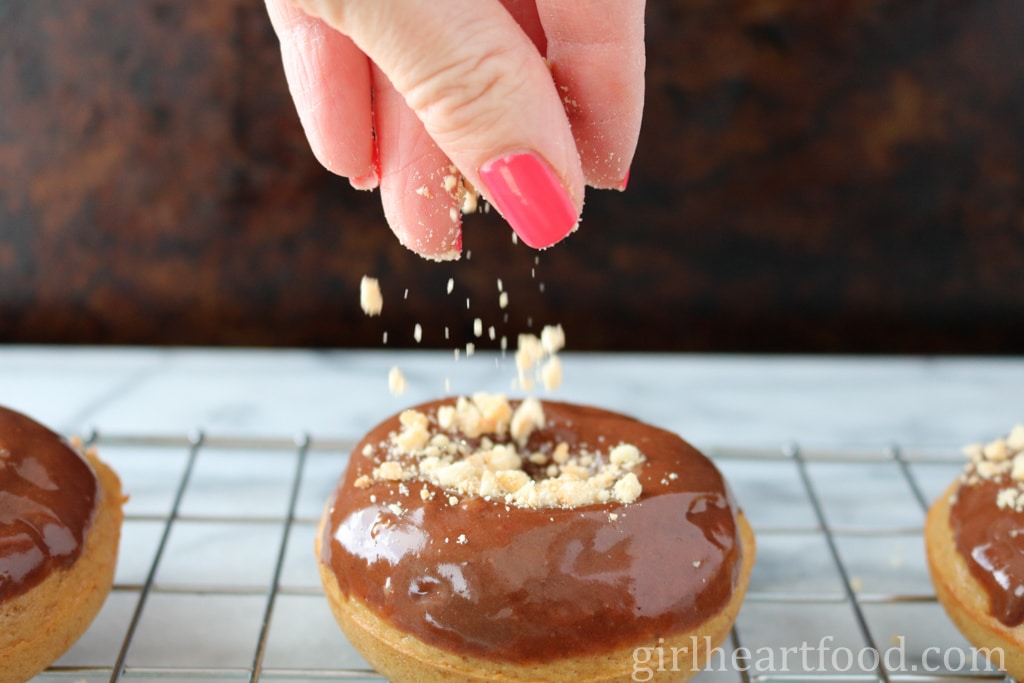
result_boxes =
[0,346,1024,446]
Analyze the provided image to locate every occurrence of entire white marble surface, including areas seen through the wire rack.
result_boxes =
[6,347,1024,683]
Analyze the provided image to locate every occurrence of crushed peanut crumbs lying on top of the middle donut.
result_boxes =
[356,393,645,509]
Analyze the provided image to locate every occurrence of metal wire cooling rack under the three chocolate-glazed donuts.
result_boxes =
[29,432,1011,683]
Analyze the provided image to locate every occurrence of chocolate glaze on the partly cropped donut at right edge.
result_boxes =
[949,479,1024,627]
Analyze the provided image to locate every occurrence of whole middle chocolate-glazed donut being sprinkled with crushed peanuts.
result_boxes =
[315,394,755,683]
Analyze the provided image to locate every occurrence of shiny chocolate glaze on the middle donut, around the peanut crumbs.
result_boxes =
[321,401,741,661]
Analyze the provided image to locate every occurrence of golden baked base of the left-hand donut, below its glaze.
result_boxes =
[0,454,124,683]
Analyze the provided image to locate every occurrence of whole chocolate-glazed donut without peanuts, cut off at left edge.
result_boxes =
[0,408,123,683]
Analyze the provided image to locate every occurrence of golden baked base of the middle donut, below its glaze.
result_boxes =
[316,512,755,683]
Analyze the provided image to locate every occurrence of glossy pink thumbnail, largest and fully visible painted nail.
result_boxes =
[480,153,578,249]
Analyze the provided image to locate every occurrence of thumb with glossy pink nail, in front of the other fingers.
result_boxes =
[300,0,584,248]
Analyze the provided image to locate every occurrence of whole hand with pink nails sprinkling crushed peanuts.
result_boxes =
[266,0,645,260]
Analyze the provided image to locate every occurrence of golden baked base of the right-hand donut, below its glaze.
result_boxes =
[925,481,1024,680]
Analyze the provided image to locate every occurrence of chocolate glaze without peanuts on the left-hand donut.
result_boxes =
[0,408,99,600]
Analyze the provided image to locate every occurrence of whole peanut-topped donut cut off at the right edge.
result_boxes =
[925,425,1024,680]
